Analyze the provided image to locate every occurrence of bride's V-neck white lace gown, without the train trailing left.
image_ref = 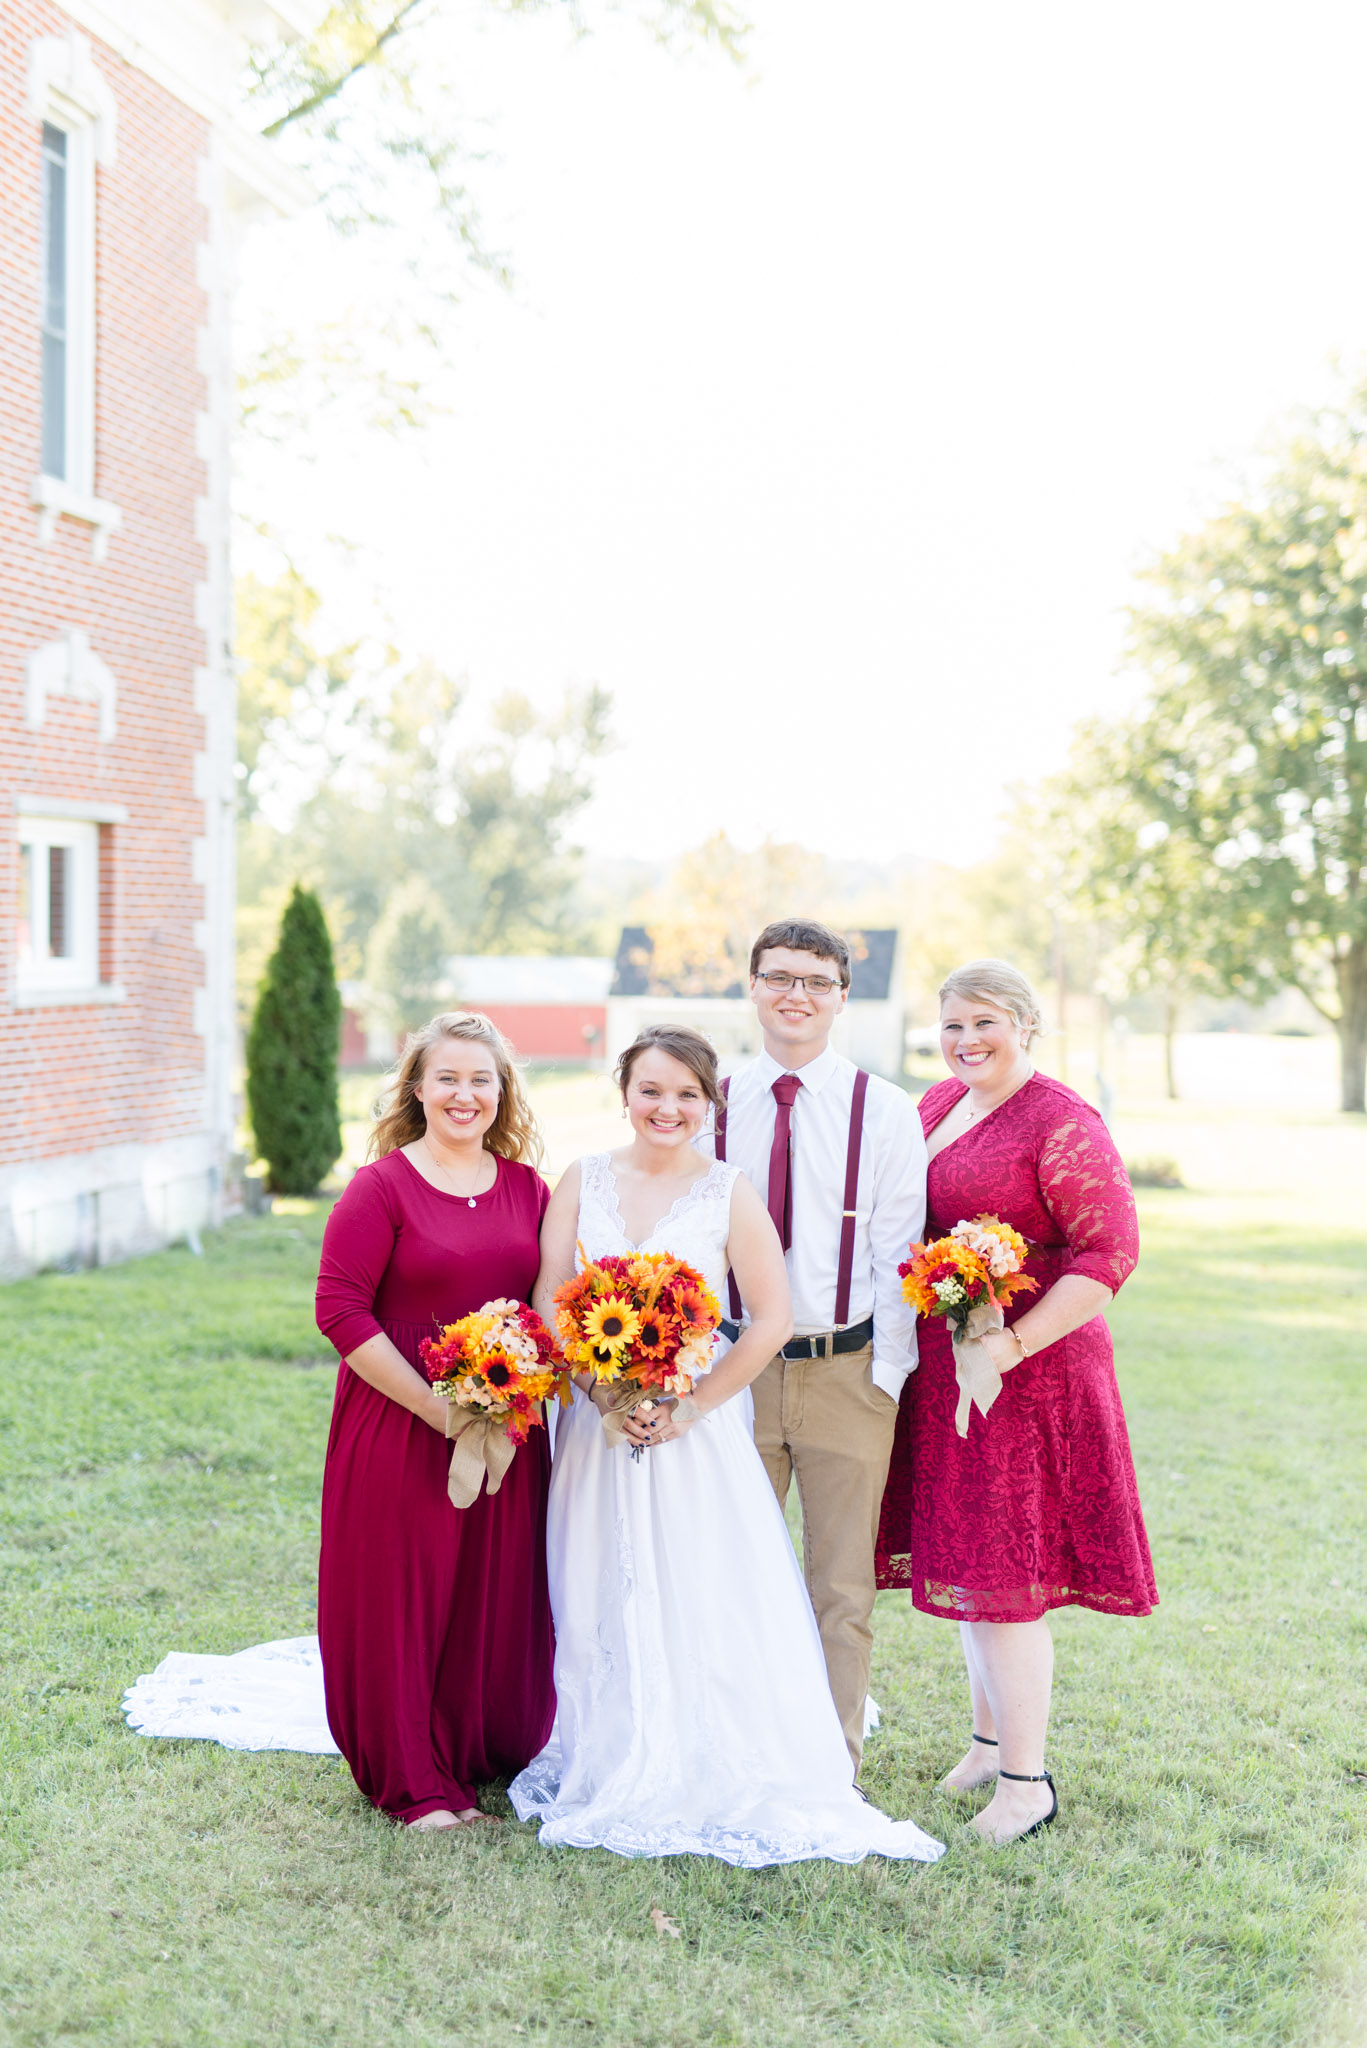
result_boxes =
[508,1153,945,1870]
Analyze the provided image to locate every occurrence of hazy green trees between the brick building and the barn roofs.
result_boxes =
[238,565,611,1028]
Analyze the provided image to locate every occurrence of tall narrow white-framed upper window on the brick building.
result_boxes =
[29,29,119,561]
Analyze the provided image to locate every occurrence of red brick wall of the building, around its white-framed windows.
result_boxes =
[0,0,207,1165]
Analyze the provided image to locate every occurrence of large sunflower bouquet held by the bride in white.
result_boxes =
[555,1245,721,1458]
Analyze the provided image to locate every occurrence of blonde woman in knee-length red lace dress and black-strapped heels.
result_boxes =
[877,961,1158,1841]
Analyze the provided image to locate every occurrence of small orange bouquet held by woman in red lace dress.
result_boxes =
[898,1217,1039,1436]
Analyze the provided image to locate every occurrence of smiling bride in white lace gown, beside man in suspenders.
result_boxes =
[508,1028,945,1868]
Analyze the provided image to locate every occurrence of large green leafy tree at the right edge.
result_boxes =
[1125,385,1367,1112]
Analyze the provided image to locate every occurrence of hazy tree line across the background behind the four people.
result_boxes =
[240,387,1367,1112]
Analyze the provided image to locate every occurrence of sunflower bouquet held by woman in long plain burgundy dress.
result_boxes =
[418,1300,568,1507]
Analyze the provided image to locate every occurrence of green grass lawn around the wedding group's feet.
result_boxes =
[0,1194,1367,2048]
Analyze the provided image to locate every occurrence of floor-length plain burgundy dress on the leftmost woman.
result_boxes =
[318,1151,555,1821]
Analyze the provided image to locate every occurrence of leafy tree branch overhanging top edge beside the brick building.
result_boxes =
[242,0,748,440]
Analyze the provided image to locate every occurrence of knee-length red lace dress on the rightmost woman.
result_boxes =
[877,1073,1158,1622]
